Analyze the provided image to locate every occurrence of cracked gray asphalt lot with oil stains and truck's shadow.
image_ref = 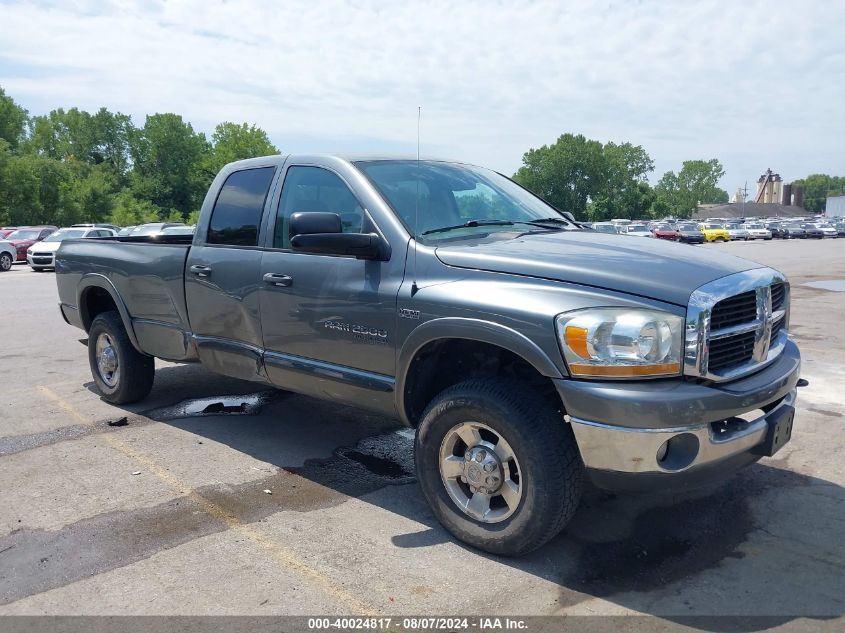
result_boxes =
[0,238,845,630]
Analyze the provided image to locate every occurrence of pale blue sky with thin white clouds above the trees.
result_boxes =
[0,0,845,194]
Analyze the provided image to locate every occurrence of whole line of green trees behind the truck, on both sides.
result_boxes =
[0,87,845,226]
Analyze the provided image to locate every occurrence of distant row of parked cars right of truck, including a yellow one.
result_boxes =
[585,218,845,244]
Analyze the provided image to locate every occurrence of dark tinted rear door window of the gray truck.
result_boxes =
[206,167,275,246]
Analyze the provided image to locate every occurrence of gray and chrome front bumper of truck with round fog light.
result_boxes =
[555,341,801,490]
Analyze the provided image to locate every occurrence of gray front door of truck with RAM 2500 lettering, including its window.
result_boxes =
[259,165,404,412]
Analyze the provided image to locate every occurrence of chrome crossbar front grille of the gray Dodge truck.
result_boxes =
[684,268,789,381]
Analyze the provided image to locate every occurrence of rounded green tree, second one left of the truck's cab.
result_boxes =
[130,113,210,216]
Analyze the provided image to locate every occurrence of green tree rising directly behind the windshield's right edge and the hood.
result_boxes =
[513,134,607,219]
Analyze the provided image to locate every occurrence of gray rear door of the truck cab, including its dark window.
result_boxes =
[185,166,276,380]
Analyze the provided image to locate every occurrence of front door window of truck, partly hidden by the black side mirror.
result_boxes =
[273,166,364,249]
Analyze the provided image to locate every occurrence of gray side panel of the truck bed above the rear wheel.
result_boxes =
[56,235,192,360]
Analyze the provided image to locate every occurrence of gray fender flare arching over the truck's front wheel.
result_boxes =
[395,317,566,423]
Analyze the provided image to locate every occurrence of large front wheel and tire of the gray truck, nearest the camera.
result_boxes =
[414,379,584,555]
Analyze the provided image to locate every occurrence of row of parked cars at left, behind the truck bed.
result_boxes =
[0,222,195,272]
